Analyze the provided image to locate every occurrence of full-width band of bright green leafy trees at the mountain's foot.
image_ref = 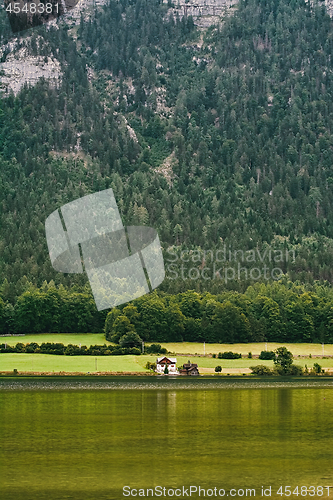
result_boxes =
[0,279,333,344]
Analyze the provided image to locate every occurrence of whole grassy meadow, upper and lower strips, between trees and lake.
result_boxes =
[0,333,333,373]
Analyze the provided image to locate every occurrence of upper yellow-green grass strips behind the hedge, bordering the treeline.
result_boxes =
[0,333,333,358]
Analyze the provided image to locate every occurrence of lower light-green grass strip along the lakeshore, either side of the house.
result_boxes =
[0,353,333,373]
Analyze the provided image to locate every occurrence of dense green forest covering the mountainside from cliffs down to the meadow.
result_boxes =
[0,0,333,342]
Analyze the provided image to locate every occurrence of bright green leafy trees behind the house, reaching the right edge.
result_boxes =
[105,282,333,343]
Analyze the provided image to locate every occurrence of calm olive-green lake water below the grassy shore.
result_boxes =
[0,377,333,500]
